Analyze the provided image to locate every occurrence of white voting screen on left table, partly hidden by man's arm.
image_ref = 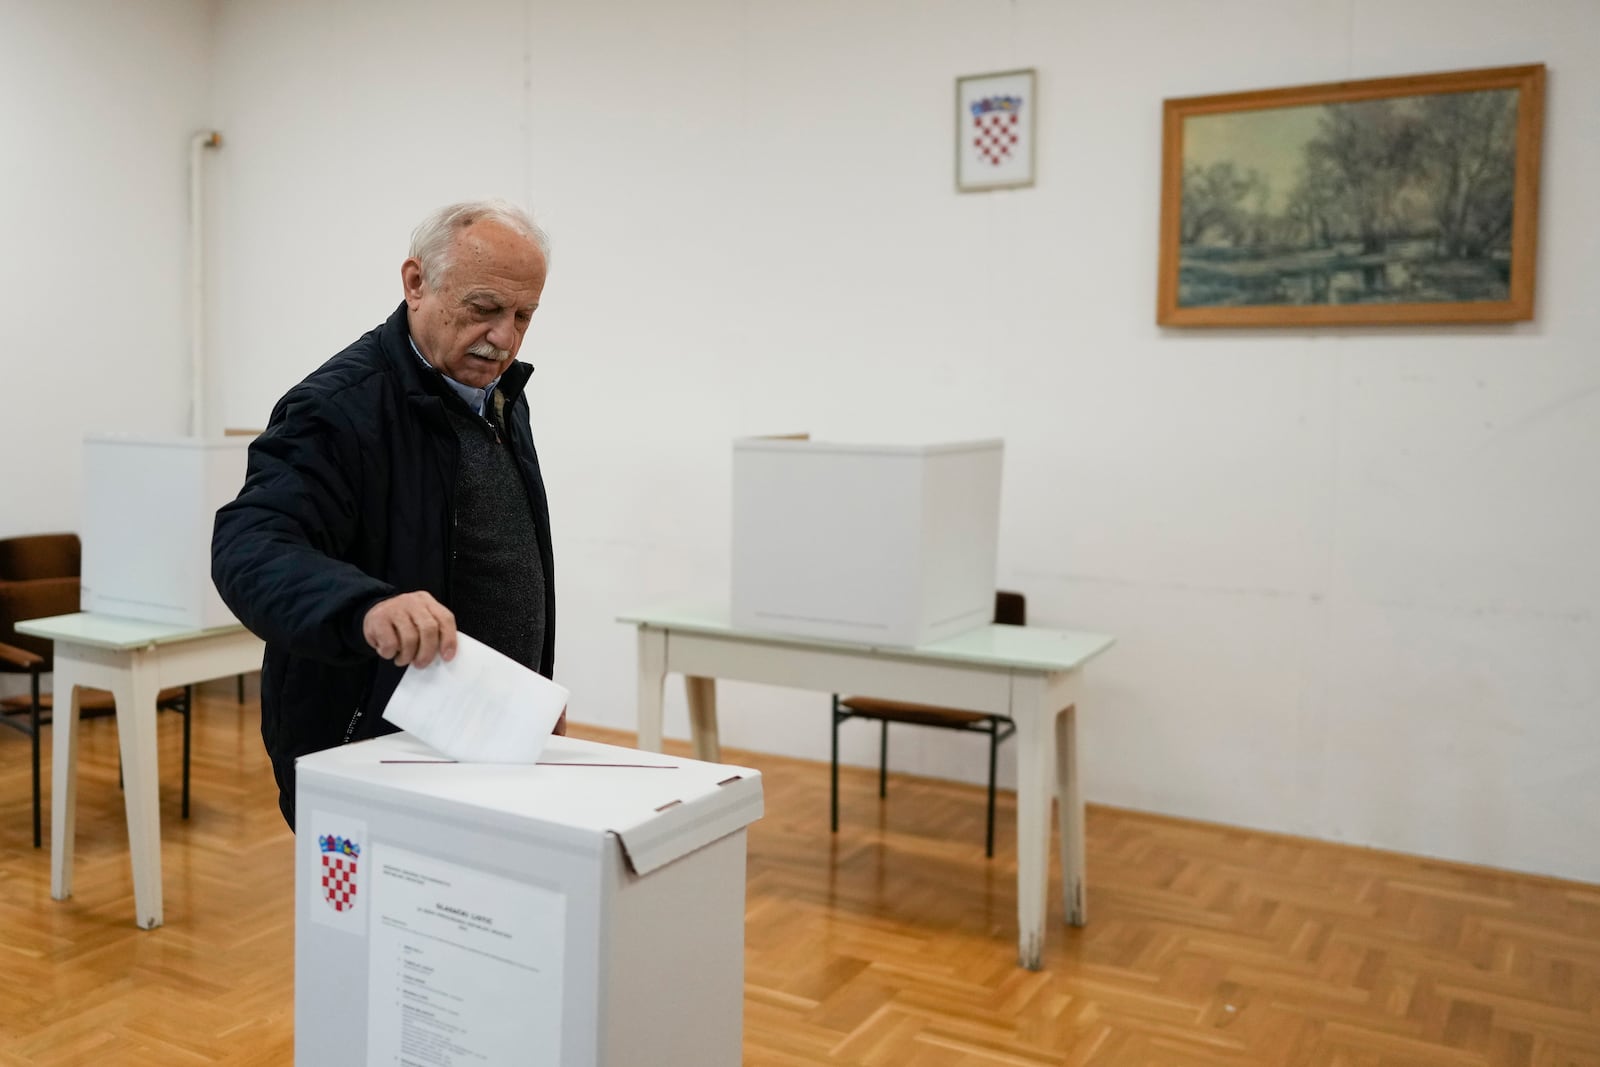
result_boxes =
[78,434,250,630]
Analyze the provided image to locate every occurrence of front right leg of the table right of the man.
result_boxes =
[1011,675,1056,971]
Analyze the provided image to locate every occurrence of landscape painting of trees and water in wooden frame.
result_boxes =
[1155,64,1544,326]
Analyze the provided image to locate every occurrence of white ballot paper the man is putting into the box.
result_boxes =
[384,633,570,763]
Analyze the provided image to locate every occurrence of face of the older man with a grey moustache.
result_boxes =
[400,219,546,389]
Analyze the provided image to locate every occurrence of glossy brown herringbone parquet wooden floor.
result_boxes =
[0,683,1600,1067]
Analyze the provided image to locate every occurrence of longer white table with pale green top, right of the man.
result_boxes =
[618,606,1114,971]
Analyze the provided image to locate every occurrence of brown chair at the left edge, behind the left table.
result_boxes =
[0,533,192,848]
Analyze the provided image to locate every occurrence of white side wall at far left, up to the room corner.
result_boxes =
[0,0,211,536]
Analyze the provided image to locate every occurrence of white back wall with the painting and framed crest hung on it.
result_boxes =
[72,0,1600,880]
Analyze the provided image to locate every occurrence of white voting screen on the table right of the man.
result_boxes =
[731,437,1005,646]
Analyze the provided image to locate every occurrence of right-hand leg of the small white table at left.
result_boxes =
[112,651,162,929]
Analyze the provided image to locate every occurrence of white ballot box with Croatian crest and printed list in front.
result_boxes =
[294,733,762,1067]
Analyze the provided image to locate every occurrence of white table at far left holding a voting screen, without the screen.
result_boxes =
[16,611,262,929]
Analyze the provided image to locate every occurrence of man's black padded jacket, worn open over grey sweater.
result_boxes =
[211,304,555,827]
